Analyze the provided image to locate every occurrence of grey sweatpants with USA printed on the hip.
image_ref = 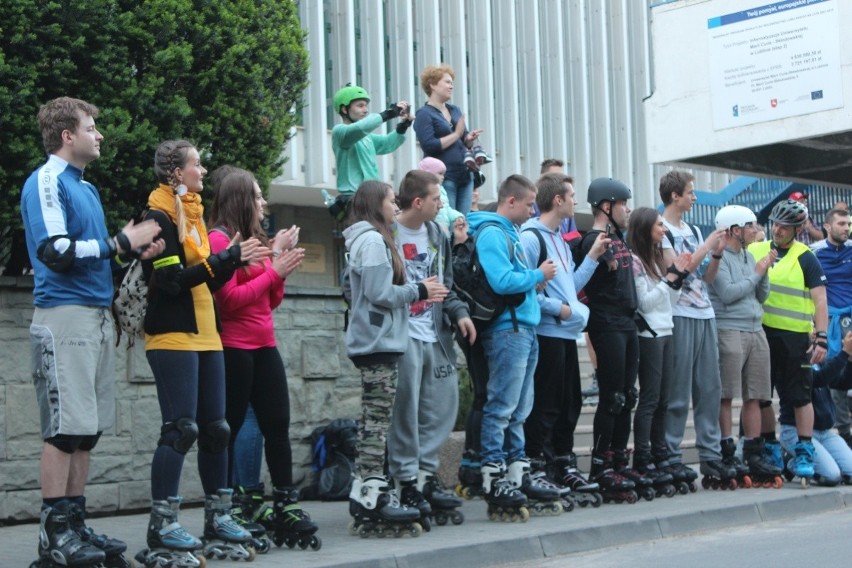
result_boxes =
[388,337,459,481]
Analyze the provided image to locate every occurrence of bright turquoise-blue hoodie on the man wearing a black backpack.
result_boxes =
[468,211,544,332]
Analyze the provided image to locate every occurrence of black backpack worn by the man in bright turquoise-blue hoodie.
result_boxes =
[453,222,526,331]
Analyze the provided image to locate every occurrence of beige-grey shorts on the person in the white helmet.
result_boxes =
[718,329,772,400]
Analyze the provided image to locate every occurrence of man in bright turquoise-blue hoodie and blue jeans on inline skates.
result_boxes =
[469,175,557,510]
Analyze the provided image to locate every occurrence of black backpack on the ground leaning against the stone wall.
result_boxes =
[302,418,358,501]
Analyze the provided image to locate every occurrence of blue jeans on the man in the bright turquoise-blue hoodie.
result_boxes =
[480,327,538,463]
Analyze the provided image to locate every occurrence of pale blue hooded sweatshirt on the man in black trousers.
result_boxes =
[521,219,598,339]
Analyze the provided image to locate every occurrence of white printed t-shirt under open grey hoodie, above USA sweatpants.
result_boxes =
[396,223,438,343]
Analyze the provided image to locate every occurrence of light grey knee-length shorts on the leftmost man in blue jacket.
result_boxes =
[30,306,115,439]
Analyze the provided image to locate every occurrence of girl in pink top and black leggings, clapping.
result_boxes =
[209,167,319,548]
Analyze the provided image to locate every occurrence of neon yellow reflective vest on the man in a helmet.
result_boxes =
[748,241,816,333]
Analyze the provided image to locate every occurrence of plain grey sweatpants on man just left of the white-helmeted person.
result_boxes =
[666,316,722,462]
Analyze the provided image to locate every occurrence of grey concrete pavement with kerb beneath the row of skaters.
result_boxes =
[0,484,852,568]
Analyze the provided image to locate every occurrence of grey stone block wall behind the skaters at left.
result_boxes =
[0,272,360,522]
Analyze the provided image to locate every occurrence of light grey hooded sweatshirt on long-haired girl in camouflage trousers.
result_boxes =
[342,221,426,366]
